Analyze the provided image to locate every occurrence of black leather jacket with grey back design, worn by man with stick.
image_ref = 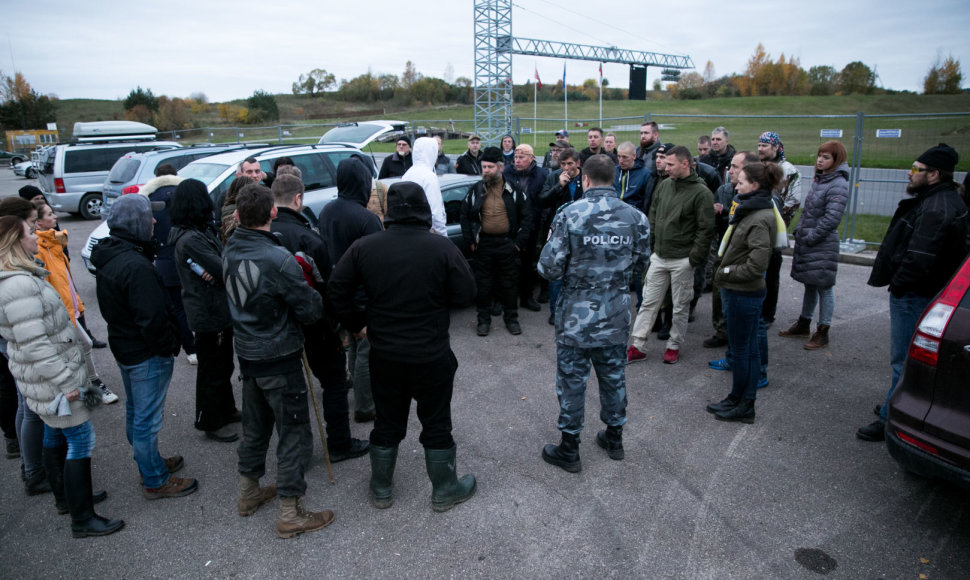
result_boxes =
[222,227,323,362]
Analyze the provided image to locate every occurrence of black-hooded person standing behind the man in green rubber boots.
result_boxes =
[317,157,383,423]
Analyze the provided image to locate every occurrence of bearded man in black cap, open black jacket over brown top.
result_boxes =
[461,147,533,336]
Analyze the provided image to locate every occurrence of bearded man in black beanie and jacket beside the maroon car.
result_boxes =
[856,143,968,441]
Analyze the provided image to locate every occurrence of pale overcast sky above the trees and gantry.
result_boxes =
[0,0,970,101]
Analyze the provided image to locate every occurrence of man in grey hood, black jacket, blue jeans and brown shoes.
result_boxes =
[91,195,199,499]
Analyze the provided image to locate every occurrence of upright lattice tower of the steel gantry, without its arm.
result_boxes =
[475,0,512,145]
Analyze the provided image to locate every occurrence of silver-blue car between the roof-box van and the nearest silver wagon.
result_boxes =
[102,143,268,211]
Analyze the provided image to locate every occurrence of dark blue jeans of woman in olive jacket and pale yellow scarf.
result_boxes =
[721,288,765,401]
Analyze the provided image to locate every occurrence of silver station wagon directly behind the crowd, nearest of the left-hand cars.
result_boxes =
[81,145,377,273]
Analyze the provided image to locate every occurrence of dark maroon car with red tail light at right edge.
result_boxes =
[886,258,970,490]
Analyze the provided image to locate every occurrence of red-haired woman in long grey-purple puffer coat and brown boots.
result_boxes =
[778,141,849,350]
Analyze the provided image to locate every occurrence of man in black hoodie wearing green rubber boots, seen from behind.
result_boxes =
[327,181,475,511]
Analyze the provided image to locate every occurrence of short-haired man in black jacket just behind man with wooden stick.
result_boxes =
[270,174,368,463]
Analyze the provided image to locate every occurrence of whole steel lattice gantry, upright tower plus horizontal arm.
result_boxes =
[474,0,694,145]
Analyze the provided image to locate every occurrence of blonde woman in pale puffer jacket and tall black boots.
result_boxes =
[0,216,125,538]
